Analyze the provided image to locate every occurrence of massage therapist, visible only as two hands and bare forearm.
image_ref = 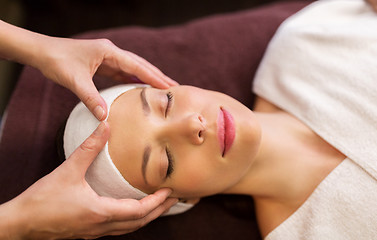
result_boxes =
[0,20,177,239]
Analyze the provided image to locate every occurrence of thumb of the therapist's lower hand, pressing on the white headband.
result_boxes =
[67,121,110,175]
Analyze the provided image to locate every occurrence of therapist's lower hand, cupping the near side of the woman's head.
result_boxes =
[0,122,177,239]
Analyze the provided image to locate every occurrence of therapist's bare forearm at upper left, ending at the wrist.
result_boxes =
[0,20,48,67]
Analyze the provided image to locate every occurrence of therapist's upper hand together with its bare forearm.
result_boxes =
[0,20,177,120]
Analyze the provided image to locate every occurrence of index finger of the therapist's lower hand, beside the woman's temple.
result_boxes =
[105,188,171,221]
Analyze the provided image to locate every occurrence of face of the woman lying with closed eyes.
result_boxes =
[108,86,260,198]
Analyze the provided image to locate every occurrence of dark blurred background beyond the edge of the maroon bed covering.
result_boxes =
[0,0,290,118]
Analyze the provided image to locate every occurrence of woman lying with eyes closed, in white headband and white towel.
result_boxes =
[64,1,377,239]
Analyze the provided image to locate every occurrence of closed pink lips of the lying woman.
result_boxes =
[217,107,236,157]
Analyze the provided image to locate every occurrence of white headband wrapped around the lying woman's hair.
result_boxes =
[63,84,193,215]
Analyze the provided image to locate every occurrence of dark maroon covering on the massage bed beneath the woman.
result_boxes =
[0,1,308,240]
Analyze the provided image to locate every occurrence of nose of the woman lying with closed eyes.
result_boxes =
[171,113,206,145]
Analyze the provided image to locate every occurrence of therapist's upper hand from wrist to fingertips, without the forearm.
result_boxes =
[36,37,177,120]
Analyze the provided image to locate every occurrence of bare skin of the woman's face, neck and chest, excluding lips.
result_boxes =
[104,86,345,236]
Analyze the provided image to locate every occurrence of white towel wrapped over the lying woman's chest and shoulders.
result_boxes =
[254,0,377,239]
